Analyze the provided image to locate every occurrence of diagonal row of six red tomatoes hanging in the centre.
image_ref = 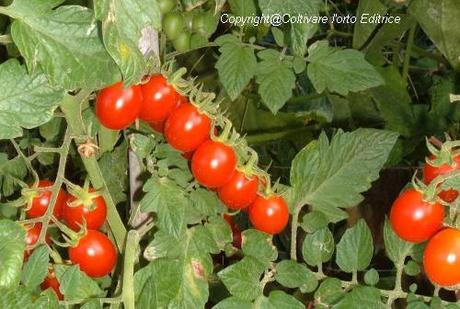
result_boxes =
[96,74,289,238]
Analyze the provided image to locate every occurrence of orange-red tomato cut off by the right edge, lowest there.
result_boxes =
[423,228,460,286]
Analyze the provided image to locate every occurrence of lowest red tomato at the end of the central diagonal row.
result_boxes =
[249,195,289,235]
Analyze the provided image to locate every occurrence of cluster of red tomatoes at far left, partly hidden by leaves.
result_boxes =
[25,180,117,299]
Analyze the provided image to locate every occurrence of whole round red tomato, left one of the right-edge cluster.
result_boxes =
[390,189,444,243]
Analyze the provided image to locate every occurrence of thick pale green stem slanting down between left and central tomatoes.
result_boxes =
[61,93,126,252]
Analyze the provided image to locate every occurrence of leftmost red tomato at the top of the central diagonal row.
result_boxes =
[96,82,142,130]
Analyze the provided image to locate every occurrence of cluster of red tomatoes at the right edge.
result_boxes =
[390,152,460,286]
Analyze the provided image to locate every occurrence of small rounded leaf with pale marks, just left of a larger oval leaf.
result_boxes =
[302,227,335,266]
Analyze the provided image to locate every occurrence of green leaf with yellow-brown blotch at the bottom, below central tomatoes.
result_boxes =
[137,225,219,308]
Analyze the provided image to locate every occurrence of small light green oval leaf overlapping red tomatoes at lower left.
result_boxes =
[21,246,49,291]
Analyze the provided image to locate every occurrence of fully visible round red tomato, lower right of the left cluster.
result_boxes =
[69,230,117,278]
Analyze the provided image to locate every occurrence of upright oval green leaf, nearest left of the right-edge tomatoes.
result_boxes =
[336,219,374,273]
